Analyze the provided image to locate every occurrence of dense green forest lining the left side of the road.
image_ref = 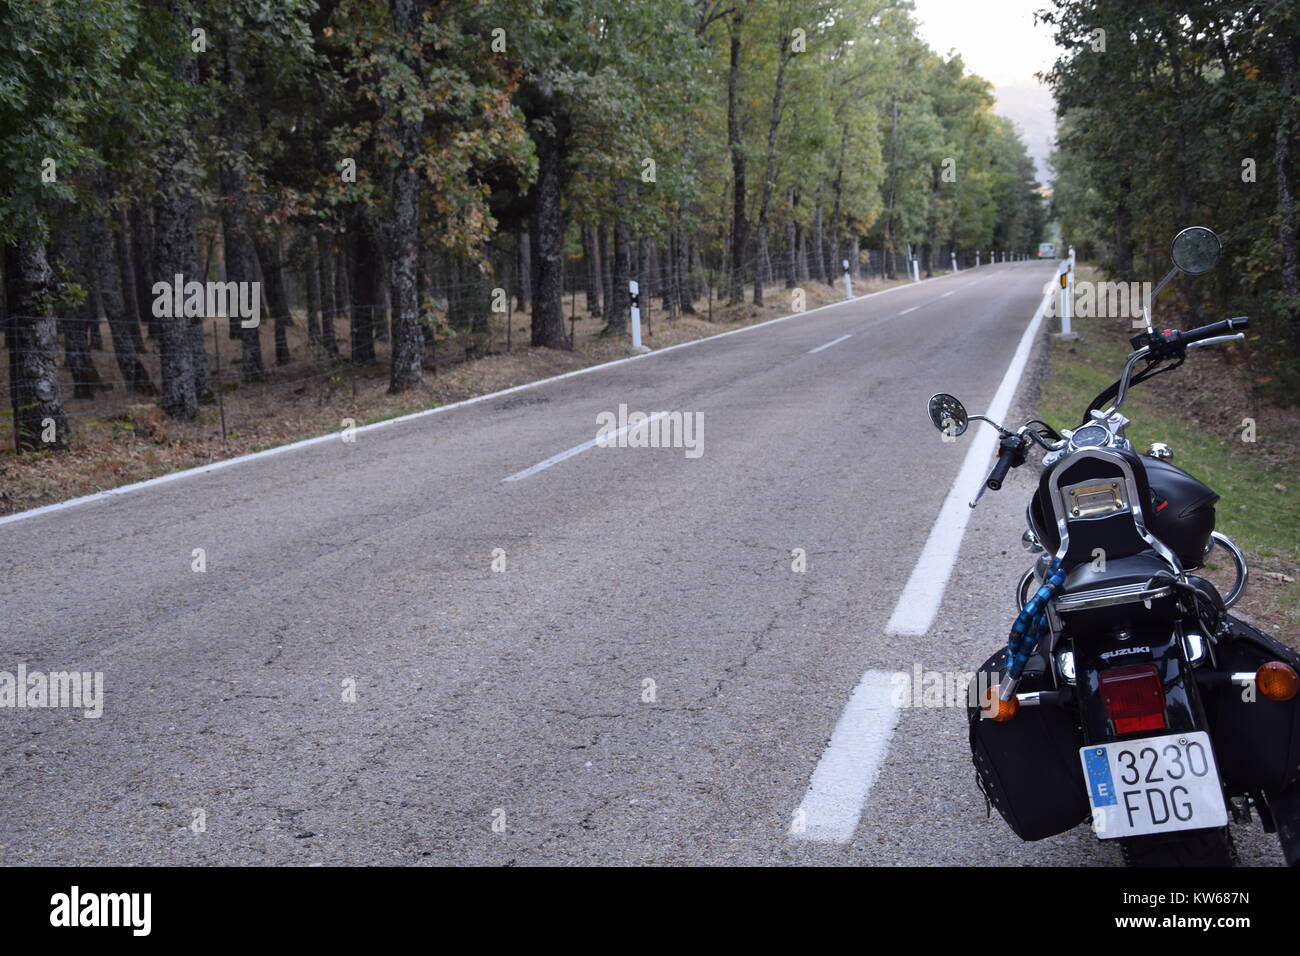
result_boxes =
[0,0,1045,454]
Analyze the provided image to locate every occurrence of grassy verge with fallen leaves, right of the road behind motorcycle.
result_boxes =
[1037,291,1300,644]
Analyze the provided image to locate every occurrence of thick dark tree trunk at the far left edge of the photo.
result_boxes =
[4,237,70,454]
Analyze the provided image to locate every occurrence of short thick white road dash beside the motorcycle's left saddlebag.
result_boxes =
[790,671,907,843]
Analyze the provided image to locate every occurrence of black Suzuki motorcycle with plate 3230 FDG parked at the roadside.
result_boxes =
[928,226,1300,866]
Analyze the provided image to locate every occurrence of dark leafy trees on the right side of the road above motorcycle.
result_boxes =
[1043,0,1300,405]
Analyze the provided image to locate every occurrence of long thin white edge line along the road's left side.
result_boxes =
[0,265,982,524]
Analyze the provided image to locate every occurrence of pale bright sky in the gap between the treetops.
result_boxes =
[914,0,1057,182]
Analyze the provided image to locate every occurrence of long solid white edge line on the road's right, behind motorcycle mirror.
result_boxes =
[885,278,1053,635]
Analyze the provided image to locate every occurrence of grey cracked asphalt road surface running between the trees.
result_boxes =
[0,263,1279,865]
